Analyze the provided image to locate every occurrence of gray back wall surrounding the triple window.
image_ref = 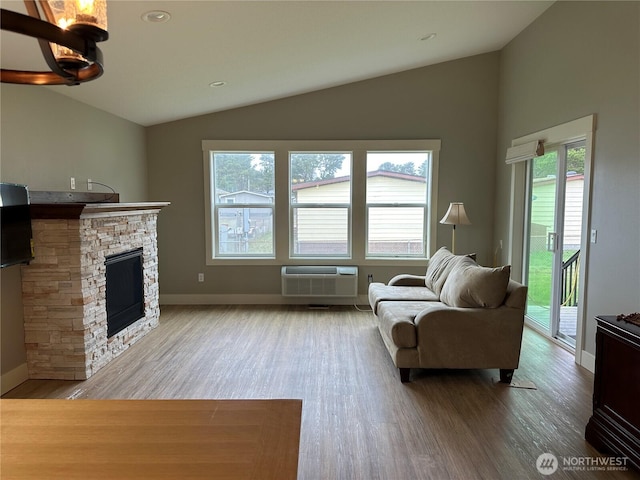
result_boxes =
[147,52,499,295]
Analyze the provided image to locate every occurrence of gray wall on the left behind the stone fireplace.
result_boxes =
[0,84,147,374]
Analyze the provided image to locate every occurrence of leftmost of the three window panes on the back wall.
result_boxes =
[210,151,275,258]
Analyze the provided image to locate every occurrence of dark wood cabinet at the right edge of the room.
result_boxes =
[585,315,640,470]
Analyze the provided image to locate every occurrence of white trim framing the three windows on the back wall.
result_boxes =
[202,139,441,266]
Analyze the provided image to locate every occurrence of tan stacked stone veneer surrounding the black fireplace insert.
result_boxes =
[22,210,160,380]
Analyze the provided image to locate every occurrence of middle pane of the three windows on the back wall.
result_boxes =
[289,152,351,257]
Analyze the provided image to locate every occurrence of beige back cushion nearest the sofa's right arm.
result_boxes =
[440,258,511,308]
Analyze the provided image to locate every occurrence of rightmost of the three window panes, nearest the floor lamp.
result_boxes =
[366,151,431,257]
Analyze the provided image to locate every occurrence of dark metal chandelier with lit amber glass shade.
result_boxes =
[0,0,109,85]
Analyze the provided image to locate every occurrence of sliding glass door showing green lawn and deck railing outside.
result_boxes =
[524,142,586,347]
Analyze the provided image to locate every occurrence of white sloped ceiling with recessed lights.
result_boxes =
[0,0,553,126]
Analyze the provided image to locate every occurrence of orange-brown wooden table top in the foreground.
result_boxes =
[0,399,302,480]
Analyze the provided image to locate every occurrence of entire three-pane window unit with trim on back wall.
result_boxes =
[202,140,440,265]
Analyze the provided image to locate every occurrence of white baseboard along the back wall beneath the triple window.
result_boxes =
[160,293,369,305]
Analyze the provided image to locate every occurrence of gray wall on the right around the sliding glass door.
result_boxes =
[495,2,640,354]
